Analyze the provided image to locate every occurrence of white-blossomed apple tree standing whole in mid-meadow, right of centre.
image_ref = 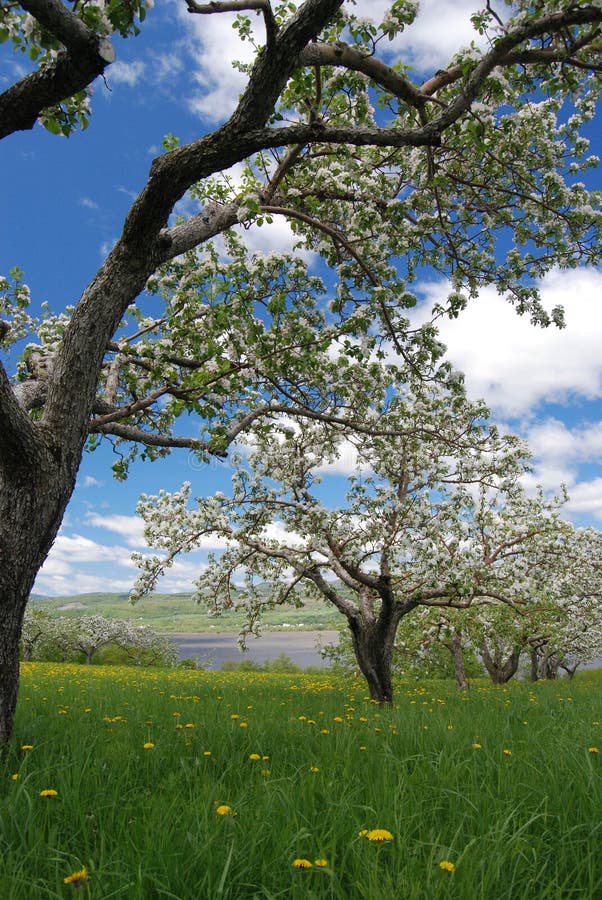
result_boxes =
[134,372,569,701]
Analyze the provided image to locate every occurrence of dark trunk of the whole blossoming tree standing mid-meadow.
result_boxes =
[349,616,398,703]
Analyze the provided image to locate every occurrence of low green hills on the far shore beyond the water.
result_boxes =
[29,592,342,634]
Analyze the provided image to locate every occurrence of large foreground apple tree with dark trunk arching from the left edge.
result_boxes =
[0,0,602,743]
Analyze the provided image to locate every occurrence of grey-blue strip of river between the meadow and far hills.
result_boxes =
[165,631,338,669]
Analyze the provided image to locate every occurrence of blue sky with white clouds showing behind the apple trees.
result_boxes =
[0,0,602,594]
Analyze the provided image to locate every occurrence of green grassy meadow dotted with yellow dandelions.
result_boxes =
[0,663,602,900]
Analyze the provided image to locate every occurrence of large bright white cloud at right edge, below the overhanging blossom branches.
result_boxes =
[423,269,602,417]
